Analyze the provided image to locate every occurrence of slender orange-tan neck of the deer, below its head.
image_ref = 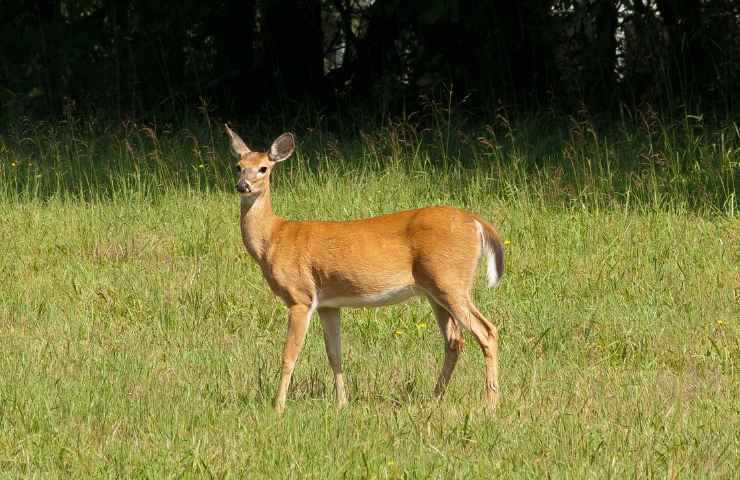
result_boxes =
[241,188,282,263]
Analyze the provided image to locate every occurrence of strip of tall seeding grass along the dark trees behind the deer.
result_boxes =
[0,107,740,215]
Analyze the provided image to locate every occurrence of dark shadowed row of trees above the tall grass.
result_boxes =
[0,0,740,120]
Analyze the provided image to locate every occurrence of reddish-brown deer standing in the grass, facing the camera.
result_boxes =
[225,124,504,413]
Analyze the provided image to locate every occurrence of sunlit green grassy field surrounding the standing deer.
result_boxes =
[0,115,740,478]
